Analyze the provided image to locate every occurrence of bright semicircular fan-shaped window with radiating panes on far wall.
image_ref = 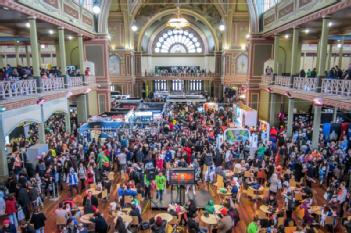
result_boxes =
[154,29,203,53]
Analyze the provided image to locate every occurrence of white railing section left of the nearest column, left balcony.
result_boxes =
[0,79,37,99]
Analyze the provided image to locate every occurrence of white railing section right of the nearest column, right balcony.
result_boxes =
[321,79,351,96]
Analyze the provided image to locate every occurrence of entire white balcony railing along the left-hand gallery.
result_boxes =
[0,76,96,99]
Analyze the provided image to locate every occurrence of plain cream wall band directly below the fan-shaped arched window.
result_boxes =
[141,56,215,74]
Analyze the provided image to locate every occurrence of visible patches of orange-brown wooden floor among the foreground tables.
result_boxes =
[44,173,346,233]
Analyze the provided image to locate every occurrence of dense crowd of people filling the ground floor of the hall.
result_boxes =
[0,98,351,233]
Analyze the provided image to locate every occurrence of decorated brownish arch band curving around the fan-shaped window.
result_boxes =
[137,9,219,51]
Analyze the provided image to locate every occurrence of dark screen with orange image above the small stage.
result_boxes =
[169,168,195,185]
